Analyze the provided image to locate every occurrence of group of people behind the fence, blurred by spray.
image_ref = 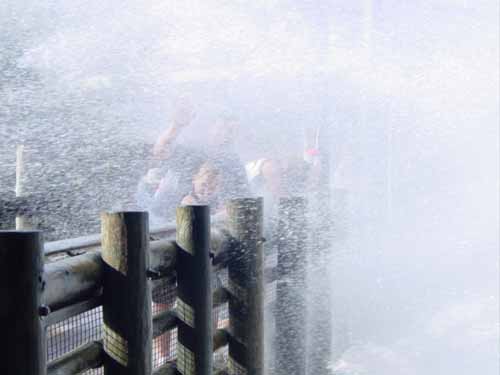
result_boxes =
[137,107,319,229]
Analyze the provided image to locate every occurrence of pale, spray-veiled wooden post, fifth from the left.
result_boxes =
[275,197,307,375]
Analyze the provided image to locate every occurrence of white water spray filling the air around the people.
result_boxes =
[0,0,500,375]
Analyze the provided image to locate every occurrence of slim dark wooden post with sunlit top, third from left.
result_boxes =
[176,206,213,375]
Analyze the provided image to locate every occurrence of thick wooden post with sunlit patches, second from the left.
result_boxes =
[101,212,152,375]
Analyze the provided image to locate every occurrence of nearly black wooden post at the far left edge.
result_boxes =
[0,231,46,375]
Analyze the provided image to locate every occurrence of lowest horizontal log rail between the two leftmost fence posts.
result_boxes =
[47,341,104,375]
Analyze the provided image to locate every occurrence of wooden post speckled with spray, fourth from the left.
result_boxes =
[228,198,264,375]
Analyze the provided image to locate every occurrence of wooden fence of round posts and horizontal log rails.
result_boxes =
[0,198,330,375]
